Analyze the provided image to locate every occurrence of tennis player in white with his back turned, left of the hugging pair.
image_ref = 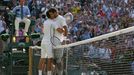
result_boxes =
[38,12,63,75]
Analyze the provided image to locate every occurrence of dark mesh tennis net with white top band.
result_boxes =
[29,26,134,75]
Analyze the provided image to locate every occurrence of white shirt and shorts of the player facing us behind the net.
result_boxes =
[54,15,67,63]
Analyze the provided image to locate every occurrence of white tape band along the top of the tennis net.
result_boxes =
[31,26,134,49]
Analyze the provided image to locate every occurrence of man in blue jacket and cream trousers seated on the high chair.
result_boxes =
[13,0,31,36]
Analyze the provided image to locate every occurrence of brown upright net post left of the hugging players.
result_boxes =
[28,47,33,75]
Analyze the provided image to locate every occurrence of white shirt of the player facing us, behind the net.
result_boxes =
[54,15,67,42]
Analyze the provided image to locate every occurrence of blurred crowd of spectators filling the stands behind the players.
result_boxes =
[0,0,134,42]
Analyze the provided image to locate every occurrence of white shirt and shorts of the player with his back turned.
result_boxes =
[41,19,57,58]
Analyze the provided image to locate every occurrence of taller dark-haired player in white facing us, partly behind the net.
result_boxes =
[48,8,68,75]
